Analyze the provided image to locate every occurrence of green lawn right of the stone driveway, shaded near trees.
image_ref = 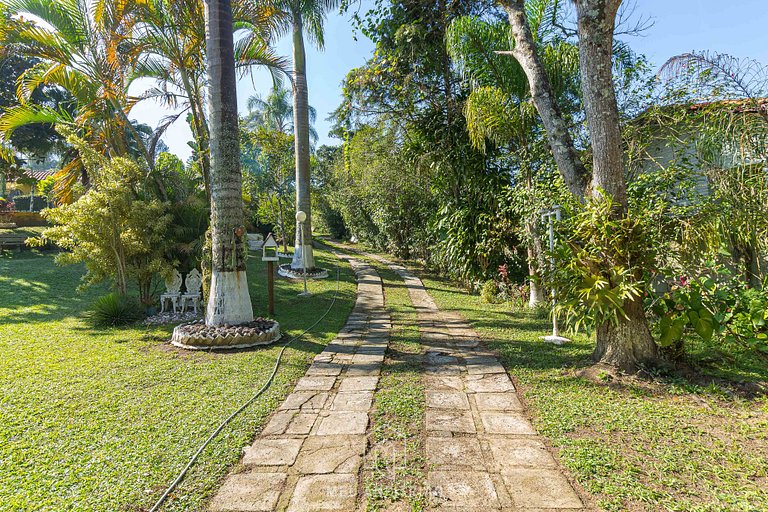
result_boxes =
[422,275,768,511]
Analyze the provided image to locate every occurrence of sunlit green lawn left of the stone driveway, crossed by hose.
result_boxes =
[0,247,355,511]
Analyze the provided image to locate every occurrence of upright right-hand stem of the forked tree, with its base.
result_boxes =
[576,0,657,371]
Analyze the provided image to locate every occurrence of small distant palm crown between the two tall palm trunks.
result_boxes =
[245,85,318,144]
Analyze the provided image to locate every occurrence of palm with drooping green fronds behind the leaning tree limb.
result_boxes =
[446,6,578,306]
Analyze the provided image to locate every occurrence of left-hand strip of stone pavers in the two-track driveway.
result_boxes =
[210,256,391,512]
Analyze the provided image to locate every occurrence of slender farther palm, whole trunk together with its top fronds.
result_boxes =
[278,0,339,268]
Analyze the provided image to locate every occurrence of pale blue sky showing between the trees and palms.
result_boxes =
[132,0,768,159]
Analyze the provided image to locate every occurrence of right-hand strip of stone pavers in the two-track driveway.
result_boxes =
[366,255,587,512]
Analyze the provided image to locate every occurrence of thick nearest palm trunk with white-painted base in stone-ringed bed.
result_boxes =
[205,0,253,325]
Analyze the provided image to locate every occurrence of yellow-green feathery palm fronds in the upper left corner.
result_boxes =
[0,0,164,199]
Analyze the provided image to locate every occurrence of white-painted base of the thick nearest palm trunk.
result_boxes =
[205,270,253,325]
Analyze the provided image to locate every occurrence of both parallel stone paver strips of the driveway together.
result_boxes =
[210,254,587,512]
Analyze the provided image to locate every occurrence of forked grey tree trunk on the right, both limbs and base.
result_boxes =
[500,0,657,371]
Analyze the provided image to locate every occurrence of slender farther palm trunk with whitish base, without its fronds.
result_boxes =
[291,12,315,269]
